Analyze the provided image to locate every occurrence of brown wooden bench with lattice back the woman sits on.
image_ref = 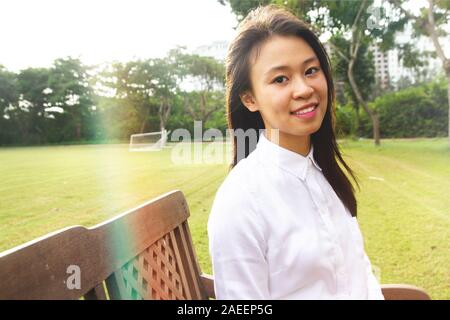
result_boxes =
[0,191,429,300]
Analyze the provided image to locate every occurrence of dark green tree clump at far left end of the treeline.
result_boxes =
[0,58,96,144]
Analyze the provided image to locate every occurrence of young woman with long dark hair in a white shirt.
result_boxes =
[208,6,383,299]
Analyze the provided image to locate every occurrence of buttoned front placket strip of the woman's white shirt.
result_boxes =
[305,160,349,296]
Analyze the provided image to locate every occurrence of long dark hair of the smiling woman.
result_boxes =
[226,5,358,217]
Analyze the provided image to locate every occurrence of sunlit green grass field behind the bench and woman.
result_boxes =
[0,139,450,299]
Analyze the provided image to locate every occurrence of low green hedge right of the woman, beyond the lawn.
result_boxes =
[336,79,448,138]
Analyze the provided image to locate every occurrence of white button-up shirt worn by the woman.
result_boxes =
[208,134,384,299]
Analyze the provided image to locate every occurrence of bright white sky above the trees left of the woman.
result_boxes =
[0,0,236,71]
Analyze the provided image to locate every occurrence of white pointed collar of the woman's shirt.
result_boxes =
[256,131,322,180]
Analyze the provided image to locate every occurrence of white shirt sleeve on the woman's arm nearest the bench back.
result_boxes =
[208,184,270,300]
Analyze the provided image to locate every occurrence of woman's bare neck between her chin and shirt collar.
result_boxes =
[265,129,311,157]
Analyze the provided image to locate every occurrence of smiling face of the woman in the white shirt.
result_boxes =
[241,36,328,148]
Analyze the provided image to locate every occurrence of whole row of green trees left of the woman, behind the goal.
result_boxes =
[0,48,226,145]
